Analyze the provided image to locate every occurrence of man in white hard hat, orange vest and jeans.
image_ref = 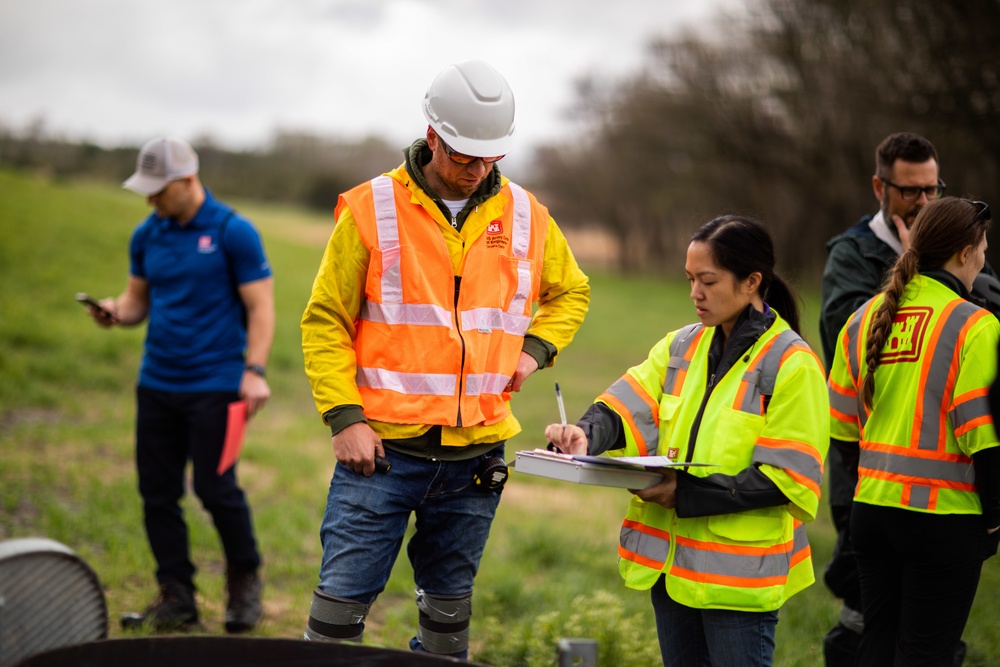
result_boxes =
[302,61,590,658]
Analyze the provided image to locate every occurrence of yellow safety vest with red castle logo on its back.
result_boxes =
[829,275,1000,514]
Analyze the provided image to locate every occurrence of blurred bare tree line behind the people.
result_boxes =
[7,0,1000,279]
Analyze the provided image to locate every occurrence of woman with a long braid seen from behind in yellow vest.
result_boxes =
[829,197,1000,666]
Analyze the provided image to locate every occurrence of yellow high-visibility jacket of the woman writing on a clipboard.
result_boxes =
[597,316,829,611]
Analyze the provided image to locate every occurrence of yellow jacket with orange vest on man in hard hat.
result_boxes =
[302,165,590,447]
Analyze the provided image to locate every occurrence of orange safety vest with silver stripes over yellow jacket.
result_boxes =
[336,175,548,426]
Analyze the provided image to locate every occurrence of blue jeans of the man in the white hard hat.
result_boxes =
[319,445,504,624]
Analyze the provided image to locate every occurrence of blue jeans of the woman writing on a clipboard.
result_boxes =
[650,575,778,667]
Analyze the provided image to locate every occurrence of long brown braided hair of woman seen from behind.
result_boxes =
[861,197,990,409]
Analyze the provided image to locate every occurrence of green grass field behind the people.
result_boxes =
[0,166,1000,667]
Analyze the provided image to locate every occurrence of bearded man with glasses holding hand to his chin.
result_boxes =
[820,132,1000,667]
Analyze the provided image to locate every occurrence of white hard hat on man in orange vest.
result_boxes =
[424,60,514,157]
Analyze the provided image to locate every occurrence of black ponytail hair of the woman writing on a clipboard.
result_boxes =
[691,215,801,334]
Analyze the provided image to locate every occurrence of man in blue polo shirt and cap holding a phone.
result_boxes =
[83,138,274,632]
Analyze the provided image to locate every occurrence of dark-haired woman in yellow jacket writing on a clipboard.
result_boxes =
[545,216,829,667]
